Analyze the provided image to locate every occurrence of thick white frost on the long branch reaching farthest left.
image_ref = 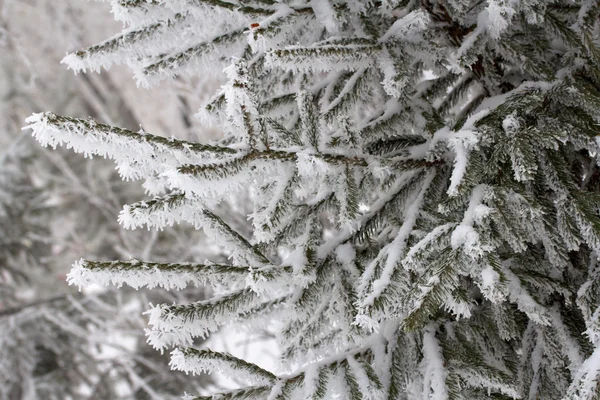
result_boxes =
[24,113,293,212]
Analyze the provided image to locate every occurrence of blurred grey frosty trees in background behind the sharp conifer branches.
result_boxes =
[0,0,237,400]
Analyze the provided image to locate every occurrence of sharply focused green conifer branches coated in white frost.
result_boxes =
[28,0,600,400]
